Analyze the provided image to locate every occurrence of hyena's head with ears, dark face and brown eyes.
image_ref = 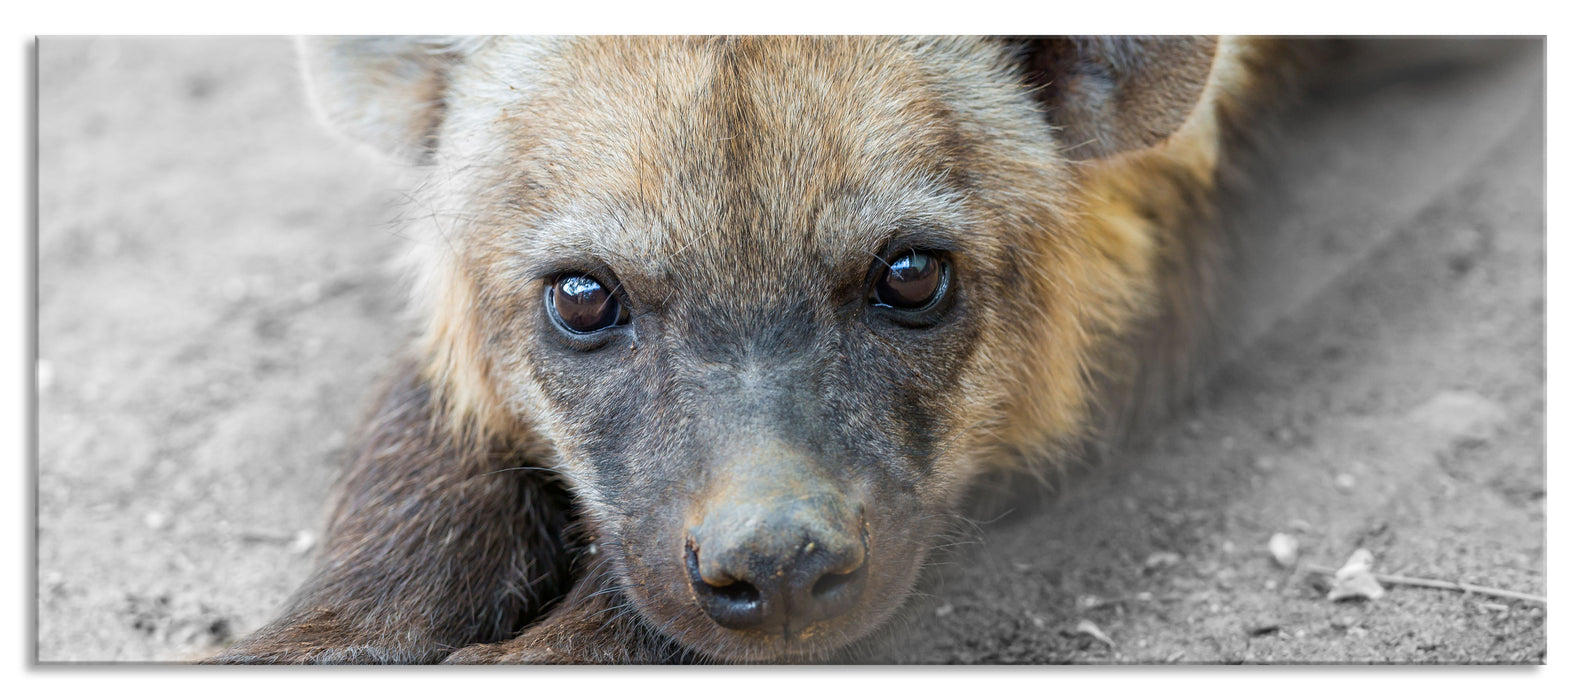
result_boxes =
[304,38,1215,660]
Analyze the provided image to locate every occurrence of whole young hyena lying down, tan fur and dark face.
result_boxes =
[215,36,1309,664]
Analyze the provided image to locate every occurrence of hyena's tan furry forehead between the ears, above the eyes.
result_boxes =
[440,38,1039,281]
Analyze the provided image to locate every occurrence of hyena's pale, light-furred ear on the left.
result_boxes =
[297,36,478,163]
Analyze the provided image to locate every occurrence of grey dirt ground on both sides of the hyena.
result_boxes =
[36,38,1547,664]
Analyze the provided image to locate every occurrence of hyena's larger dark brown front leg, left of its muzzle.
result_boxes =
[209,361,571,664]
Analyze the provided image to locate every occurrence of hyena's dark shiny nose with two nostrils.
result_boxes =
[685,500,869,635]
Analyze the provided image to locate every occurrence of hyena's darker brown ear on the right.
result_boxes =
[1009,36,1218,158]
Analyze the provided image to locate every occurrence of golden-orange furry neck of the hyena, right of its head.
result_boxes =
[1016,38,1323,474]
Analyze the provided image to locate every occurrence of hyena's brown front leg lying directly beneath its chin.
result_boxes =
[445,576,698,664]
